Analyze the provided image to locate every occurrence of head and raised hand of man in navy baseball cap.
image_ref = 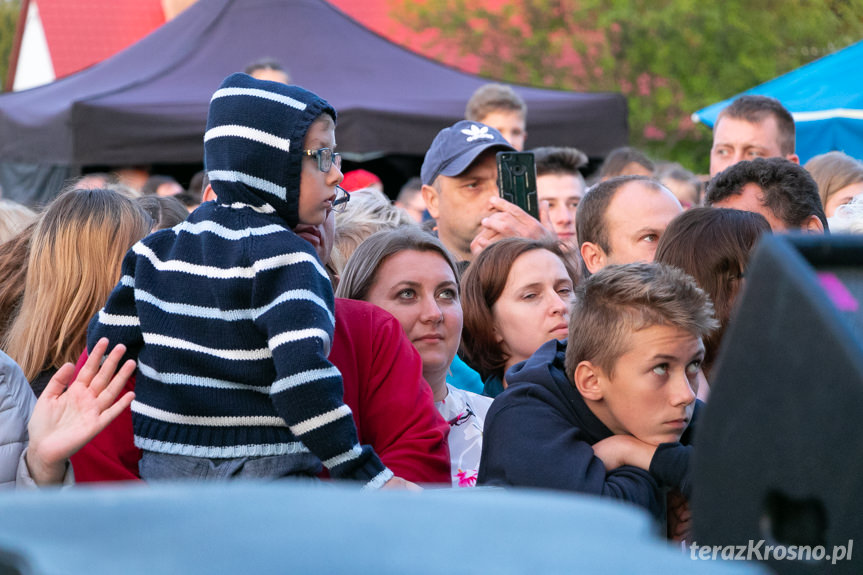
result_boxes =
[421,121,555,261]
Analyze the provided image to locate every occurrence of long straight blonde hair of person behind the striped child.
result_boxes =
[3,189,152,381]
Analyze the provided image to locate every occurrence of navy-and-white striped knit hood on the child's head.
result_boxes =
[204,74,336,229]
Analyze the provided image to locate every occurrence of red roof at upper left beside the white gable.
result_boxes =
[37,0,165,78]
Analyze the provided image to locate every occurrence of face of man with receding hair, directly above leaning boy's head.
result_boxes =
[604,181,683,272]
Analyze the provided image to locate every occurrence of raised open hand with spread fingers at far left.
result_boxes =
[26,338,135,485]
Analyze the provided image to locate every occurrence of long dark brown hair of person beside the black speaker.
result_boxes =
[656,208,770,379]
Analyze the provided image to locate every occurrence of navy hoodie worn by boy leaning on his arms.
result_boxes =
[478,340,700,517]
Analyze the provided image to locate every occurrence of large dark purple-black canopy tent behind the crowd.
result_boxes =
[0,0,627,204]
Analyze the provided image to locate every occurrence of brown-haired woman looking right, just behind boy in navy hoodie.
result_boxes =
[462,238,578,397]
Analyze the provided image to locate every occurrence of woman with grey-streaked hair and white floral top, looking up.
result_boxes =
[336,226,491,487]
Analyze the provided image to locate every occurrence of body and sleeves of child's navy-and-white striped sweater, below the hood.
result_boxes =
[88,72,392,487]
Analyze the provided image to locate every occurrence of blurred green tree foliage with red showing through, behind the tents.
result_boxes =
[392,0,863,172]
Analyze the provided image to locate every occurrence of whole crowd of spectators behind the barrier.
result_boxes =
[0,61,863,539]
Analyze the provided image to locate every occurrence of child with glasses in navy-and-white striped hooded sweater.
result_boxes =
[88,74,395,488]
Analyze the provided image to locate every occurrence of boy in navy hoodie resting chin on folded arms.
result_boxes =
[479,263,717,518]
